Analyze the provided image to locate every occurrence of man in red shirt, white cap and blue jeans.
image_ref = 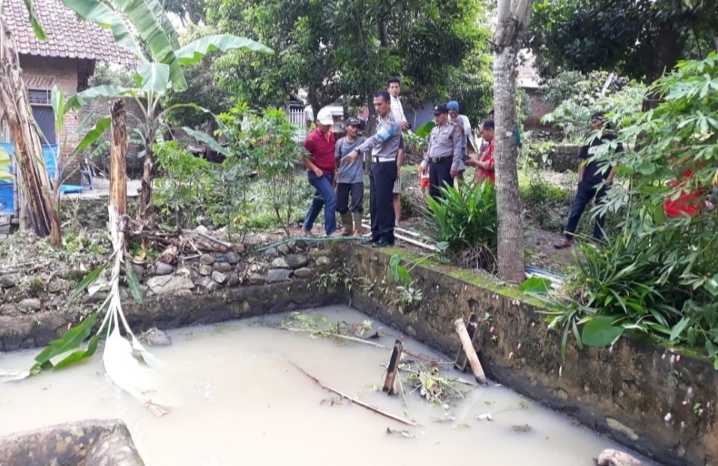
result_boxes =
[302,108,339,236]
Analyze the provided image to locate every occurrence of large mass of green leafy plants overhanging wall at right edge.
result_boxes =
[536,54,718,364]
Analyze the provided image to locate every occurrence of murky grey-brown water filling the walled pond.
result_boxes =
[0,306,652,466]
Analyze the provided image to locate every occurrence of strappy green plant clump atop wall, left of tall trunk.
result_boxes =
[425,182,497,269]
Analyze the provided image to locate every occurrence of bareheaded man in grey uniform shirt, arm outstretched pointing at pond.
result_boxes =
[346,91,401,248]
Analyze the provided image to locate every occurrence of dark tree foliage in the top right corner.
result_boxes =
[527,0,718,82]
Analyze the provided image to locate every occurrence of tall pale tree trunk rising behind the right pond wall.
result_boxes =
[494,0,531,283]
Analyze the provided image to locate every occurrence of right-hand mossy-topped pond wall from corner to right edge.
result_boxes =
[349,247,718,466]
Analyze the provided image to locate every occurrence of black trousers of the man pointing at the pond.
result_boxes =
[369,160,398,243]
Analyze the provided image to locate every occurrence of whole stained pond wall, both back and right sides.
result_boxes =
[0,243,718,466]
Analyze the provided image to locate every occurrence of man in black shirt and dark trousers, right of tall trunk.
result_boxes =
[554,113,623,249]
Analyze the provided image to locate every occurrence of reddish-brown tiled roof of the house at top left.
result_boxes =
[2,0,137,65]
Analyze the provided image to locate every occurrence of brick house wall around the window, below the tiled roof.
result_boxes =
[20,55,80,184]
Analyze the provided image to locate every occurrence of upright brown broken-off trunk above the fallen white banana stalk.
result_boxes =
[110,99,127,217]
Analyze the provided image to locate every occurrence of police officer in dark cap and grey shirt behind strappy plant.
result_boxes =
[421,104,464,199]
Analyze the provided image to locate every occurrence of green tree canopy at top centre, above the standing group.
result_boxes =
[208,0,487,114]
